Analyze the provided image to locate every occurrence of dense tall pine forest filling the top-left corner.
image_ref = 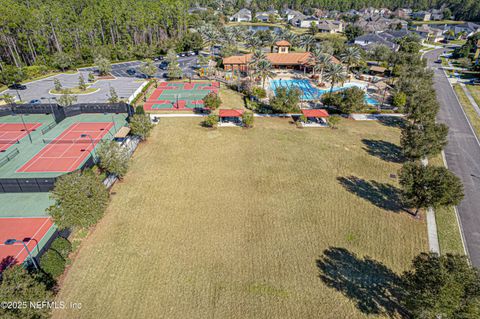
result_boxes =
[0,0,189,66]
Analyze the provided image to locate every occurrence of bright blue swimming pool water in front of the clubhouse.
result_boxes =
[270,79,380,105]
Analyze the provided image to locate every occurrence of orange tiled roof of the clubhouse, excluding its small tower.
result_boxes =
[223,52,340,65]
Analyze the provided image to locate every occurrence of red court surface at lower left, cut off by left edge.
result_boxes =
[0,217,53,271]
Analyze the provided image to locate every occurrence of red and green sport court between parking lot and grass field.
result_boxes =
[143,81,220,111]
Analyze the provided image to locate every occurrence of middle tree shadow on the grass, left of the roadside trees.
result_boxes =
[337,176,403,212]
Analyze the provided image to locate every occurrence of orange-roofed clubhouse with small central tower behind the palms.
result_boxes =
[223,40,340,72]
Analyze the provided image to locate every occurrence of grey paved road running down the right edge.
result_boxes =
[425,49,480,268]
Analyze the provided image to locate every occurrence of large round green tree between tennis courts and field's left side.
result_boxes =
[47,170,109,228]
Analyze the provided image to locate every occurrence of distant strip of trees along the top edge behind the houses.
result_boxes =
[198,0,480,21]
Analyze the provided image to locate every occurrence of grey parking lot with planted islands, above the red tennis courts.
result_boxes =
[0,71,144,103]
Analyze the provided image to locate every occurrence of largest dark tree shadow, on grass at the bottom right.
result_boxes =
[316,247,407,317]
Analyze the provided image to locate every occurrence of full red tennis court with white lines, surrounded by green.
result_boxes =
[17,122,113,173]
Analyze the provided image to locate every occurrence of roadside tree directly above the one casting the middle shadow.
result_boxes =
[400,122,448,160]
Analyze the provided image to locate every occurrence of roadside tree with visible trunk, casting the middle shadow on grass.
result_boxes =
[399,162,463,216]
